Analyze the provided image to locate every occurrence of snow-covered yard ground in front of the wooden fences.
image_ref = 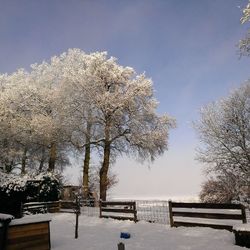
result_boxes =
[42,213,244,250]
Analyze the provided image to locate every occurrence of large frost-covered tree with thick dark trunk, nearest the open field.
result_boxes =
[77,52,174,200]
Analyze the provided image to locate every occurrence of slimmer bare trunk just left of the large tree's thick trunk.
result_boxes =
[82,144,90,199]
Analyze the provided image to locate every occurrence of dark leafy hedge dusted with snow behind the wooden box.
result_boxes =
[0,171,61,217]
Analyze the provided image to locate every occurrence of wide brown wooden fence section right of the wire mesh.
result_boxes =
[169,201,246,231]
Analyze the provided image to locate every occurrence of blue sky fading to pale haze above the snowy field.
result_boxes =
[0,0,250,198]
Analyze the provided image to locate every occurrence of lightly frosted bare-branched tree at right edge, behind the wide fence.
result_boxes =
[195,81,250,204]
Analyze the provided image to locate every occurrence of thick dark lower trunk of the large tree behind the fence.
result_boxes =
[100,141,110,201]
